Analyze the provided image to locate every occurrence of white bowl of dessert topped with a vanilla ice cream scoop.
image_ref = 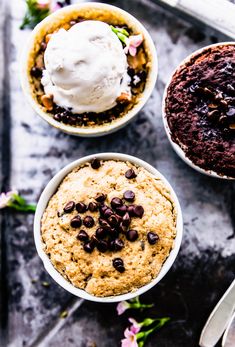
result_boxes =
[21,3,157,136]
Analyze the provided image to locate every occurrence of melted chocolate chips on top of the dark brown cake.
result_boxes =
[189,83,235,131]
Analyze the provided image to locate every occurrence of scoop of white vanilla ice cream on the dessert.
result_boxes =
[42,21,130,113]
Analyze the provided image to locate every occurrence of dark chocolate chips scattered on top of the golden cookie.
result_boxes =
[60,158,159,272]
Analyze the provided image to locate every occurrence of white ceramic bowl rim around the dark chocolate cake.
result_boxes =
[162,42,235,180]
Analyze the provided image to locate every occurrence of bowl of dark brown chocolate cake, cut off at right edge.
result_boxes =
[163,43,235,179]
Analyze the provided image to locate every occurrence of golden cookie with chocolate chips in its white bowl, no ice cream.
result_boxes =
[35,154,182,301]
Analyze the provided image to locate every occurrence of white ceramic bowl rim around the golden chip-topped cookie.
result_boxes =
[34,153,183,303]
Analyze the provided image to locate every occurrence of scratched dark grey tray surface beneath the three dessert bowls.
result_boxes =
[0,0,235,347]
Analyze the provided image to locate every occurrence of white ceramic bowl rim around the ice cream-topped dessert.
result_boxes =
[20,2,158,137]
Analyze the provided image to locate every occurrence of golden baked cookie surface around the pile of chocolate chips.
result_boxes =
[41,160,176,297]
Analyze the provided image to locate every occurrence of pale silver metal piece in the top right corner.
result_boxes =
[159,0,235,39]
